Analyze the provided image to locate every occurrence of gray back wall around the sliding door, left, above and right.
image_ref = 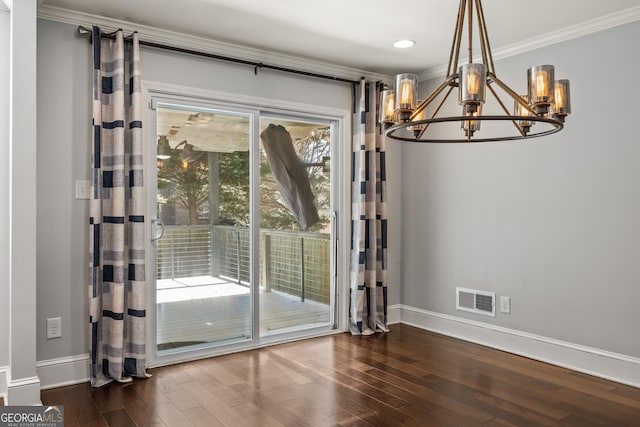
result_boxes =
[35,20,400,364]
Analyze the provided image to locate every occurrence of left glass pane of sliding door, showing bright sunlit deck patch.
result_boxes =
[154,104,252,351]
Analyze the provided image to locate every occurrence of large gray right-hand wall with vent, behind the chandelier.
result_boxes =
[401,22,640,357]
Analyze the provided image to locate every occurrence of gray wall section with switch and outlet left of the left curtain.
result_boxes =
[37,20,91,360]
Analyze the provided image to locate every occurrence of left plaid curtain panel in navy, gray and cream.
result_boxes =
[89,27,147,387]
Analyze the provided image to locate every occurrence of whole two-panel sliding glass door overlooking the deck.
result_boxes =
[152,102,336,358]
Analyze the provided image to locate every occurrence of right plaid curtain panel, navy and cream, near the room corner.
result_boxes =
[349,79,388,335]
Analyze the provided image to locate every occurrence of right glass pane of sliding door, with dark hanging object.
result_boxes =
[260,117,334,336]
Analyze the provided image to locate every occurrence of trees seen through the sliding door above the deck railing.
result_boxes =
[158,130,331,232]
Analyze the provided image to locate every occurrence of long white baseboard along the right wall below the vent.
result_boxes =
[387,304,640,387]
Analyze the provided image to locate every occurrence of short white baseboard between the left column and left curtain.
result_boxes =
[36,354,90,390]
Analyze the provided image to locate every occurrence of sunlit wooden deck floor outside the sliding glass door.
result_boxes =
[156,276,330,350]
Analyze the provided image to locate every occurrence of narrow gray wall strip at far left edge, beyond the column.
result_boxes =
[0,10,9,367]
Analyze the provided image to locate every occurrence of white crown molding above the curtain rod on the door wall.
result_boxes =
[38,5,391,82]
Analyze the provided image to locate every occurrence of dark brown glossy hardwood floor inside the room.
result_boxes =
[42,325,640,427]
